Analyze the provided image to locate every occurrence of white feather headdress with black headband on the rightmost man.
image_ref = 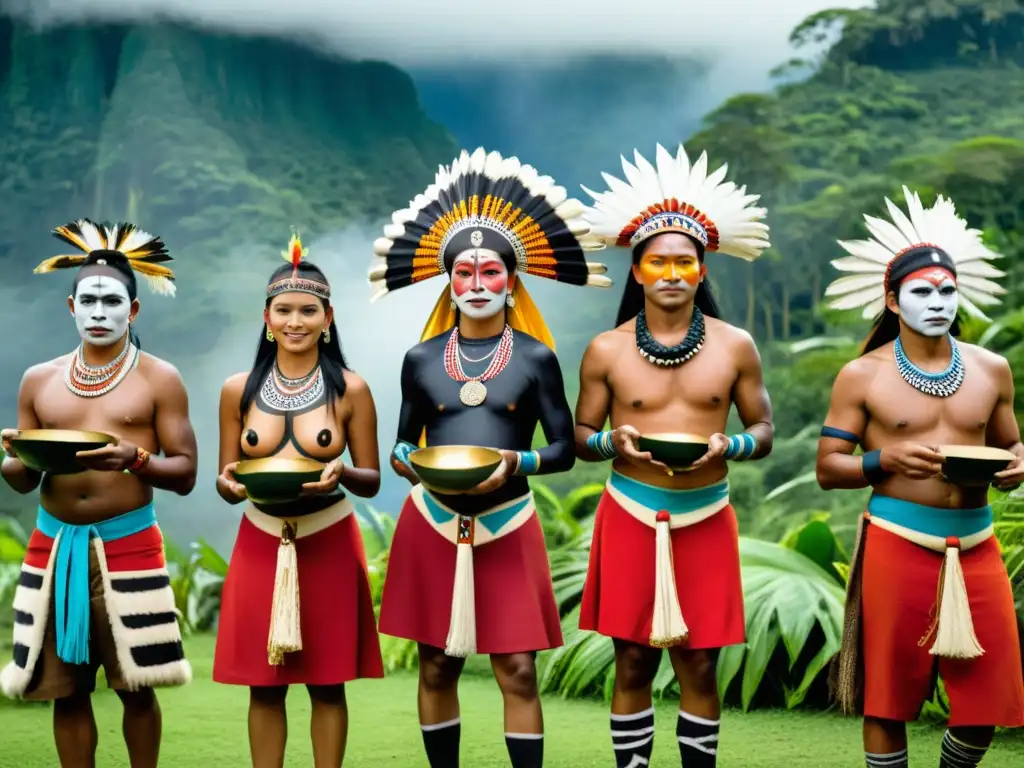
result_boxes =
[825,186,1006,321]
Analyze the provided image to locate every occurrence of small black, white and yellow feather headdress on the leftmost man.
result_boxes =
[33,219,176,296]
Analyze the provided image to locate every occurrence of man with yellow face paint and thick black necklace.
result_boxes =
[575,146,773,768]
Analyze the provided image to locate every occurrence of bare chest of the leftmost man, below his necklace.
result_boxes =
[33,371,156,436]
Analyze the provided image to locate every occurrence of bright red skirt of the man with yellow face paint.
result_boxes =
[580,490,746,649]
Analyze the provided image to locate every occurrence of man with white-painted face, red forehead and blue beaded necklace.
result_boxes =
[817,187,1024,768]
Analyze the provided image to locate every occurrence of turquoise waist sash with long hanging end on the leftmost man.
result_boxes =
[36,503,157,664]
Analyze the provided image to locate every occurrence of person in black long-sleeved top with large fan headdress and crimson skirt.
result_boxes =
[370,150,610,768]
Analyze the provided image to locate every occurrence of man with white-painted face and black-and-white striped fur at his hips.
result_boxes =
[0,219,197,768]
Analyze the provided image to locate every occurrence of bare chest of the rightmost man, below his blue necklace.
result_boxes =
[866,369,998,441]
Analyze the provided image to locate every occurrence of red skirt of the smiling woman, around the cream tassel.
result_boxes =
[213,512,384,687]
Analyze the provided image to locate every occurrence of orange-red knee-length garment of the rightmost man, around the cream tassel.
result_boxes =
[861,525,1024,728]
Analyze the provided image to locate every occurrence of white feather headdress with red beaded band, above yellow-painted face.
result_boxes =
[583,144,770,261]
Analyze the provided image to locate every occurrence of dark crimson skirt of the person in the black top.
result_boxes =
[380,499,562,654]
